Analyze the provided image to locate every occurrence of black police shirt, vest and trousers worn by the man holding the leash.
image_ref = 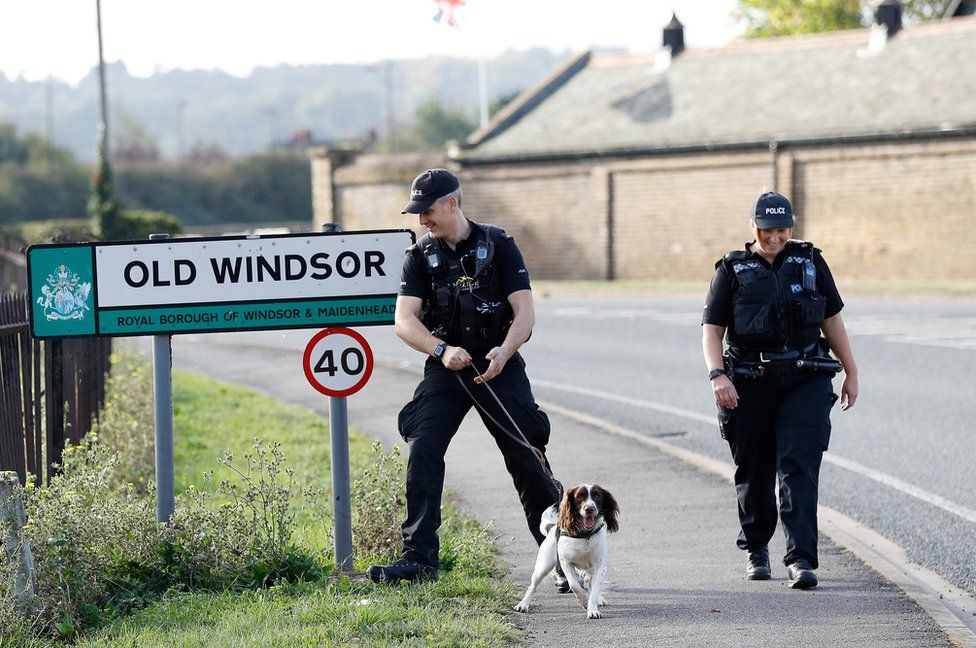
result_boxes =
[399,221,558,568]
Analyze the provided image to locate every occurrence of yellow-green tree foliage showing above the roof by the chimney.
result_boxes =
[732,0,945,38]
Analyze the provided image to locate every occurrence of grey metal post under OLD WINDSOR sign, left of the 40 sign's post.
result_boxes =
[149,234,176,524]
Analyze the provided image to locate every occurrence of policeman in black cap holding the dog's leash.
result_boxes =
[367,169,568,589]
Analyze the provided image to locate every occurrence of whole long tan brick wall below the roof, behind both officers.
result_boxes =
[313,138,976,281]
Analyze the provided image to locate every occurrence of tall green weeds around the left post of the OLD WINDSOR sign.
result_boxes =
[14,434,324,638]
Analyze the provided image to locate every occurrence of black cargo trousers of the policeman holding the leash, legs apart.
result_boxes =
[399,353,559,567]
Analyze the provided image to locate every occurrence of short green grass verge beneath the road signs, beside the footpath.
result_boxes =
[70,372,521,646]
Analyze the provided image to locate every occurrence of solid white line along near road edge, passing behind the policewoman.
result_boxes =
[532,378,976,524]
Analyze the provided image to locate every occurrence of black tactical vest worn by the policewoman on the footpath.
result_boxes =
[716,240,827,351]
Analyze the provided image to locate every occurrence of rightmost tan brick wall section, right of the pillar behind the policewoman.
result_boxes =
[793,140,976,280]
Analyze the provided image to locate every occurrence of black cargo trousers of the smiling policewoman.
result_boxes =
[719,372,837,569]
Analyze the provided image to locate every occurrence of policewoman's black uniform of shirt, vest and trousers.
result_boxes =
[702,227,844,584]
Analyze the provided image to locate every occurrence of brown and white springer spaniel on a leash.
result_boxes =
[515,484,620,619]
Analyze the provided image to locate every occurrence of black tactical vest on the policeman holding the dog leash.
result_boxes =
[416,223,514,353]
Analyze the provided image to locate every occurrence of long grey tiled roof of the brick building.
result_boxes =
[461,17,976,163]
